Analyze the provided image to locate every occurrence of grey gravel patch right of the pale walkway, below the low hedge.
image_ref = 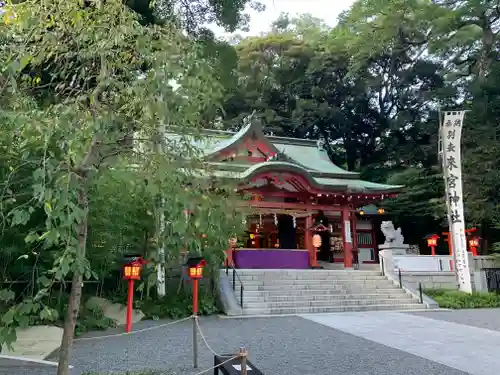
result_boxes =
[407,309,500,331]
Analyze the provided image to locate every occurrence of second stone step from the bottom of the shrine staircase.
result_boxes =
[243,298,417,309]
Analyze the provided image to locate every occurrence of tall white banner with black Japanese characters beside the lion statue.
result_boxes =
[440,111,472,293]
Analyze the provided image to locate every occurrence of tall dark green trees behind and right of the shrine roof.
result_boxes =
[222,0,500,247]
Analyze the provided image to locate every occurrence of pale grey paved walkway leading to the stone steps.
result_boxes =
[302,312,500,375]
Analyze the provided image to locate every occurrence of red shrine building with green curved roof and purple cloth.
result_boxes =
[193,119,402,269]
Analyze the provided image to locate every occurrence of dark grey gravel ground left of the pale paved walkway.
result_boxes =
[13,317,467,375]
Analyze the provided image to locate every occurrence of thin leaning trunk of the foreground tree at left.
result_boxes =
[57,184,88,375]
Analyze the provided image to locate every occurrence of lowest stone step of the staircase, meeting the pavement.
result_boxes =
[243,303,425,315]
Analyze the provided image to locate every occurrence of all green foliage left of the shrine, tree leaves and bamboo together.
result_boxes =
[0,0,244,362]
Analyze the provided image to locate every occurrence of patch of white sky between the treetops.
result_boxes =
[213,0,354,36]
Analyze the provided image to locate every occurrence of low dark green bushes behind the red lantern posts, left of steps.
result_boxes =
[137,289,219,320]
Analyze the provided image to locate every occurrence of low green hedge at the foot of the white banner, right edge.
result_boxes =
[425,289,500,309]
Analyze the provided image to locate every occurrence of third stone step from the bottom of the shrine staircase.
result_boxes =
[237,293,413,303]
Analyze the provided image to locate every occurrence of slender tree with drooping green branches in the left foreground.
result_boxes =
[0,0,245,375]
